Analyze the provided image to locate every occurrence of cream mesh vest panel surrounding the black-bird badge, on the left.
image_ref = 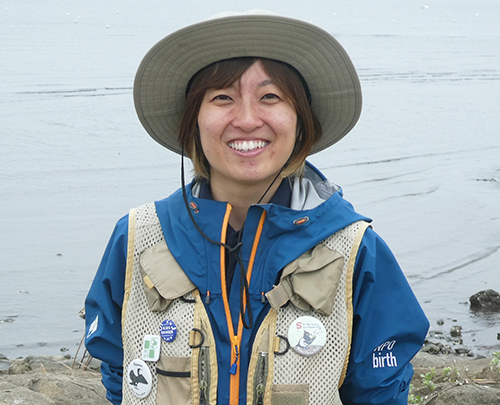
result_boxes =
[122,204,194,405]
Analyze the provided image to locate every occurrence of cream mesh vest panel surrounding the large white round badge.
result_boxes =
[273,223,359,405]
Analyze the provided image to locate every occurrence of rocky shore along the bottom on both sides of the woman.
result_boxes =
[0,346,500,405]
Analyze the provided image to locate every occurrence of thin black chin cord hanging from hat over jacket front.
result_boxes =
[181,146,284,329]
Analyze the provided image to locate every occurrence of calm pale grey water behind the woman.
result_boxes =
[0,0,500,358]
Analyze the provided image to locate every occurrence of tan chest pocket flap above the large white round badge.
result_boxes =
[290,244,344,315]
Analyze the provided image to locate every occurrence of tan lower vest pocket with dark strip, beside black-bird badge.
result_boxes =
[156,355,192,405]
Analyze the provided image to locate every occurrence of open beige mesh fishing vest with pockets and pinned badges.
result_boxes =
[122,204,368,405]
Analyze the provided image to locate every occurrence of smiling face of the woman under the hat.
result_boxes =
[198,61,297,189]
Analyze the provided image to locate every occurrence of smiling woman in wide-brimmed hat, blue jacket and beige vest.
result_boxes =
[86,12,428,405]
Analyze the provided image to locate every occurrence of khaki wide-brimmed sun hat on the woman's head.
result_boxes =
[134,12,362,154]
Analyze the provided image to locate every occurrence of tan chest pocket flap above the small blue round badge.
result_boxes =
[140,238,196,300]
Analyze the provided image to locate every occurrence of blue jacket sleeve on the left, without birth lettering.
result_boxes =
[85,217,128,404]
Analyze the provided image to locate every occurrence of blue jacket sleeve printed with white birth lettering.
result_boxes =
[340,228,429,405]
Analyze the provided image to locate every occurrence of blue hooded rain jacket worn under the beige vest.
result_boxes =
[85,165,428,405]
